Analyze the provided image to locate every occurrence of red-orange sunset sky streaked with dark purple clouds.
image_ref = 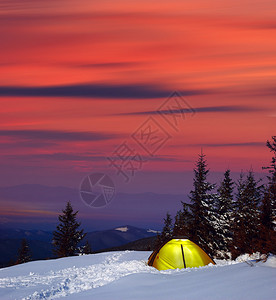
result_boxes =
[0,0,276,230]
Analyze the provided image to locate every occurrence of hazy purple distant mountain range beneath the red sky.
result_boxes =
[0,184,189,231]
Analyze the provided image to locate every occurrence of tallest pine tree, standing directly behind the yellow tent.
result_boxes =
[188,154,218,254]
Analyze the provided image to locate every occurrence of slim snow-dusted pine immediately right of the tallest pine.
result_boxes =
[216,169,234,258]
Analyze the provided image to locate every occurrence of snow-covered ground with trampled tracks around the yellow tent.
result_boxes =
[0,251,276,300]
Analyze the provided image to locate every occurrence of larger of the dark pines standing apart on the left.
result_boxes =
[53,202,85,257]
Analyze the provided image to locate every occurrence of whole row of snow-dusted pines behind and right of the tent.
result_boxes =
[156,136,276,259]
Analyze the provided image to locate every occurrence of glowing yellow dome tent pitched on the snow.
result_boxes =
[148,238,215,270]
